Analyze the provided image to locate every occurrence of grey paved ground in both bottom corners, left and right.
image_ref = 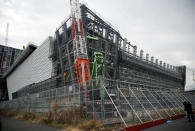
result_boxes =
[0,118,195,131]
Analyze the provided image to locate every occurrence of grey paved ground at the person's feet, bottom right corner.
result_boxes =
[143,118,195,131]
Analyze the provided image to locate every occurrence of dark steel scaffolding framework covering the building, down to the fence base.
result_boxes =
[1,5,195,126]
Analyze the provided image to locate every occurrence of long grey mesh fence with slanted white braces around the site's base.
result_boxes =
[0,80,195,126]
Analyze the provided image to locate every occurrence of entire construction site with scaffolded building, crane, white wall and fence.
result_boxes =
[0,0,195,127]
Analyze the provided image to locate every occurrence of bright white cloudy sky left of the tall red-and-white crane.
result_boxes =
[0,0,69,48]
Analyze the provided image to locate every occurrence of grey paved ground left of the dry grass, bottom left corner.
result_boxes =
[0,118,61,131]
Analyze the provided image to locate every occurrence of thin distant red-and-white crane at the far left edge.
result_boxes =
[1,23,9,74]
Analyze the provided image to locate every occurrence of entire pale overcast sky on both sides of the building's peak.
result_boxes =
[0,0,195,89]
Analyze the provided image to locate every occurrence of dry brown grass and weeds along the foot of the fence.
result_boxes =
[0,104,115,131]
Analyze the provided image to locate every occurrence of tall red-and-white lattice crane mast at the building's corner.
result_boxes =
[70,0,91,87]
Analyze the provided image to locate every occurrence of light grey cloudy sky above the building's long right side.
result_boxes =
[82,0,195,67]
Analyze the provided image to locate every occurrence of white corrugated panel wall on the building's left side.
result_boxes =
[7,37,52,99]
